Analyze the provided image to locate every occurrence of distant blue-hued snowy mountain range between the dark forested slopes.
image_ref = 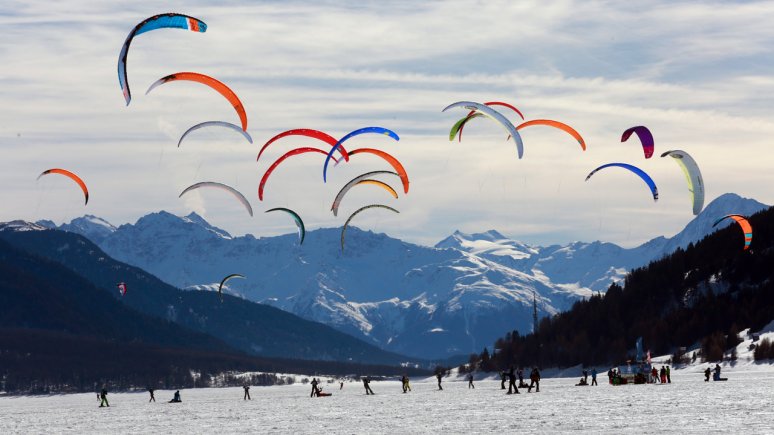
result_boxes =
[48,194,767,358]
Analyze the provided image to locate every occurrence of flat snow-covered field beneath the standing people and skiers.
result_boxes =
[0,364,774,434]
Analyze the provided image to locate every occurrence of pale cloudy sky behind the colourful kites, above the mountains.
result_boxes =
[0,0,774,246]
